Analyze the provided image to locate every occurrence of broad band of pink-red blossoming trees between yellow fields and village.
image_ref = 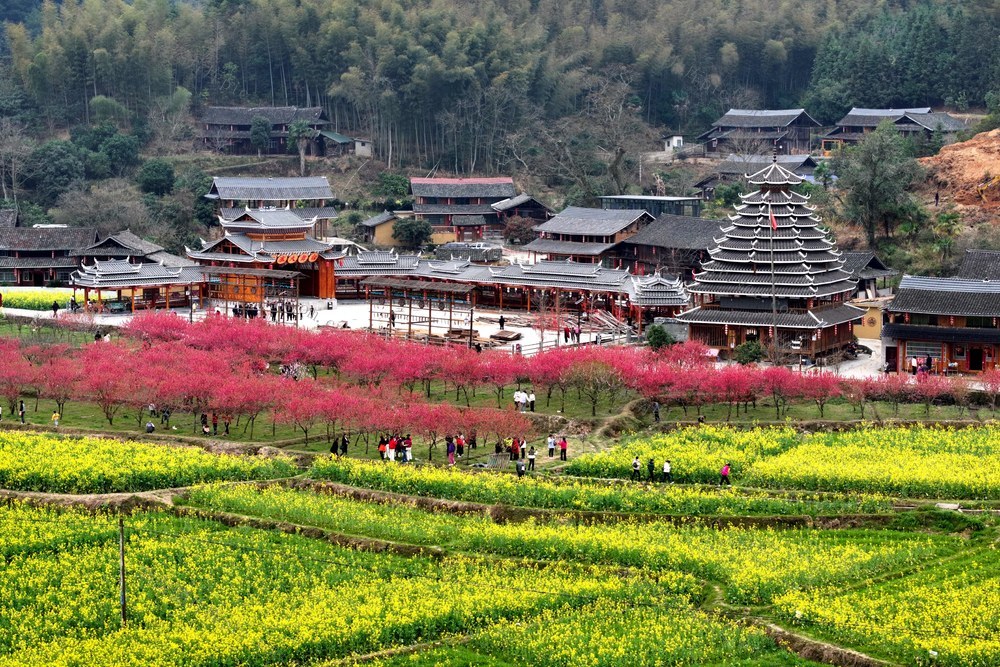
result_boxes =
[0,314,1000,451]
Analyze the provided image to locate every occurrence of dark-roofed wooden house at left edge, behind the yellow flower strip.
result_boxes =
[0,226,97,287]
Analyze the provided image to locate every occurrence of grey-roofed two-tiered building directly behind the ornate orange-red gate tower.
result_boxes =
[205,176,337,238]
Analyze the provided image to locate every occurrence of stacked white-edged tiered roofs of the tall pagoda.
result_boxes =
[679,161,861,326]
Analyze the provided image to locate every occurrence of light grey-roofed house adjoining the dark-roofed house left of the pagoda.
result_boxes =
[524,206,653,264]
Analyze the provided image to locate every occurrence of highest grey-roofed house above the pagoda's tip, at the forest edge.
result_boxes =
[698,109,820,155]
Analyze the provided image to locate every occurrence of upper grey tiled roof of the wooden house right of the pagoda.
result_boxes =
[887,276,1000,317]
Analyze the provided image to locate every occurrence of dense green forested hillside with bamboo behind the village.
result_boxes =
[0,0,1000,176]
